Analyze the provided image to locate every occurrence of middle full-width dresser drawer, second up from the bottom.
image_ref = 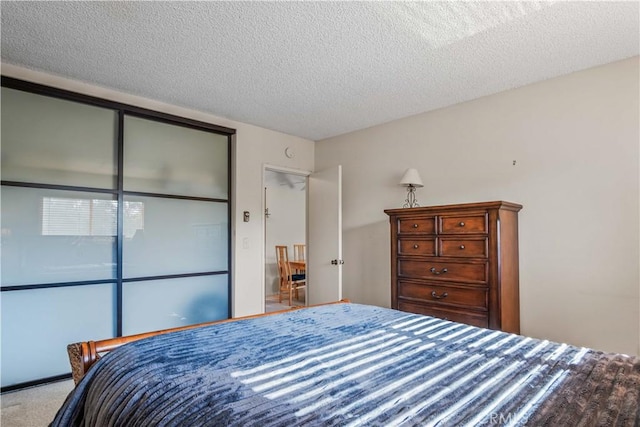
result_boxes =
[398,280,488,310]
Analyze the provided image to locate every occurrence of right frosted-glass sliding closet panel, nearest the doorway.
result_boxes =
[122,115,229,335]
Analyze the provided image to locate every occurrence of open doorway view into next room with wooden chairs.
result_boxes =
[264,170,307,312]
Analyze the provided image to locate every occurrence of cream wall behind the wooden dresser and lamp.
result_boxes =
[315,57,640,353]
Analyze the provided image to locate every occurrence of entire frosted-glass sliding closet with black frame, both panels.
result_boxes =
[0,78,235,391]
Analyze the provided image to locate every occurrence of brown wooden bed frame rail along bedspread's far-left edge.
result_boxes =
[67,299,350,384]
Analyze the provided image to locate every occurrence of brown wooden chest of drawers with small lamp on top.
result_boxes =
[385,201,522,333]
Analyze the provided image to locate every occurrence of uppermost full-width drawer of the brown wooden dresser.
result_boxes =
[398,259,488,284]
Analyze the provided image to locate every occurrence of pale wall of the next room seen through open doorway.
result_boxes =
[265,178,307,295]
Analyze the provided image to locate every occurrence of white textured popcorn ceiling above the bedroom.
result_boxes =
[0,1,640,140]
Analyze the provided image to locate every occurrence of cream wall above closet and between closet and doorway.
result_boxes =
[2,64,314,317]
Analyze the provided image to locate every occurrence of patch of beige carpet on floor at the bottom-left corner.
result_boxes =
[0,380,73,427]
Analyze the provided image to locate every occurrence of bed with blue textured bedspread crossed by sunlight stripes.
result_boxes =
[52,303,640,426]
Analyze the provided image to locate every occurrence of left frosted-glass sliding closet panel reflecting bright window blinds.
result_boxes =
[1,87,117,387]
